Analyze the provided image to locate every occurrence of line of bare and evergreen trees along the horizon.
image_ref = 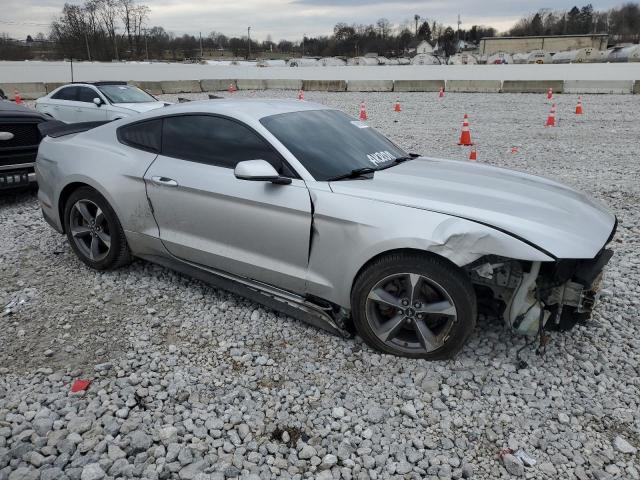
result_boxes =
[0,0,640,61]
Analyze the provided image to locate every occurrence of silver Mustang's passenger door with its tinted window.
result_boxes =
[145,115,311,293]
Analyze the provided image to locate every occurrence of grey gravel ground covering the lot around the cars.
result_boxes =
[0,91,640,480]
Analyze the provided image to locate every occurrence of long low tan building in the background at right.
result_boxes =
[479,33,609,55]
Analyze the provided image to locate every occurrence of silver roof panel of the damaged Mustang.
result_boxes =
[145,98,333,120]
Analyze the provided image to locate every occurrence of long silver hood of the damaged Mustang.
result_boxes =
[331,157,615,258]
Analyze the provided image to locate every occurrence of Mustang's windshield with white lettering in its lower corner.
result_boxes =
[260,110,407,181]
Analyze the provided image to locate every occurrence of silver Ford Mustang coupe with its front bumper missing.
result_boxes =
[36,100,616,359]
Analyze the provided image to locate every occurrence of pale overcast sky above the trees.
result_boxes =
[0,0,622,41]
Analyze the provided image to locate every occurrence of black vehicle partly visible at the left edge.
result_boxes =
[0,100,51,191]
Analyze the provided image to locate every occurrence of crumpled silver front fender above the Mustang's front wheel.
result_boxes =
[307,190,555,308]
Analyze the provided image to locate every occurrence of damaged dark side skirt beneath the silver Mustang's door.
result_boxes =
[136,255,352,338]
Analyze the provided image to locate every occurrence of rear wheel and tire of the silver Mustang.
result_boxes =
[64,187,131,270]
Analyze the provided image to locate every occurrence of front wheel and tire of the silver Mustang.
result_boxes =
[351,252,477,360]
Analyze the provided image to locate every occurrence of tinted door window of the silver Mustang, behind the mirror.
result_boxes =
[162,115,290,175]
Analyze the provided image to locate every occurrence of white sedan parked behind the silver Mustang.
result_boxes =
[36,82,169,123]
